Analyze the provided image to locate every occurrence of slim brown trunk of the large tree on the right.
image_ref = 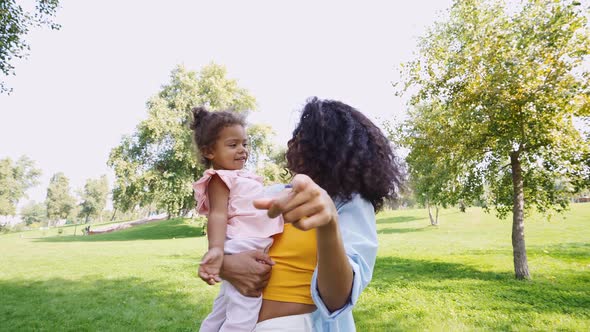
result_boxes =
[510,152,531,279]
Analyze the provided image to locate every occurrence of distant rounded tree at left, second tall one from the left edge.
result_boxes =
[45,172,76,224]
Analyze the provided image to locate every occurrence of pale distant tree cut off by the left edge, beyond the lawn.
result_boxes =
[0,156,41,216]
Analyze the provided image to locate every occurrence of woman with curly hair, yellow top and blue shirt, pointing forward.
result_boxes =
[206,98,401,331]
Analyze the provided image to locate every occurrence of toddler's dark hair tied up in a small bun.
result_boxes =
[190,106,246,167]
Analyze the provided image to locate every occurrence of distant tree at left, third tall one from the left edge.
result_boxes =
[80,175,109,223]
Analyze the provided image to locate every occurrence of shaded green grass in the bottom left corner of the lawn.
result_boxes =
[0,278,212,331]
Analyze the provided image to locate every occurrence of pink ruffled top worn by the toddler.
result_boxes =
[193,169,283,239]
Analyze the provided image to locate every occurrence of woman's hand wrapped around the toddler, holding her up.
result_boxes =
[221,250,274,297]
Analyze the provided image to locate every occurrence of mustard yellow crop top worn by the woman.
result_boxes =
[262,223,318,304]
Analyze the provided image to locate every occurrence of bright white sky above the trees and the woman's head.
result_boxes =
[0,0,451,206]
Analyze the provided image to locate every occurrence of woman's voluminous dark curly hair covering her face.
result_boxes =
[287,97,402,211]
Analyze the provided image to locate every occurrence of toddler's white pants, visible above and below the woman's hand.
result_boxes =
[199,238,272,332]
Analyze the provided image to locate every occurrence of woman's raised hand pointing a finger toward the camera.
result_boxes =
[254,174,338,231]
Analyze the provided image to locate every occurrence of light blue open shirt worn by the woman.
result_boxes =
[311,194,377,332]
